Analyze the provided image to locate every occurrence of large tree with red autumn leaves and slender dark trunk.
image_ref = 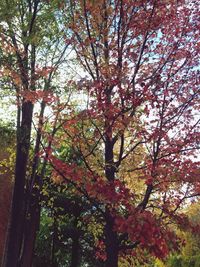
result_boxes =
[44,0,200,267]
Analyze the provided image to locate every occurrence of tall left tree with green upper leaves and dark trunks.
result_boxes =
[0,0,70,267]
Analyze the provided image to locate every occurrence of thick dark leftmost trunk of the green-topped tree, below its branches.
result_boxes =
[4,102,33,267]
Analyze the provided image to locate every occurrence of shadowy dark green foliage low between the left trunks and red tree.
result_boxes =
[34,178,102,267]
